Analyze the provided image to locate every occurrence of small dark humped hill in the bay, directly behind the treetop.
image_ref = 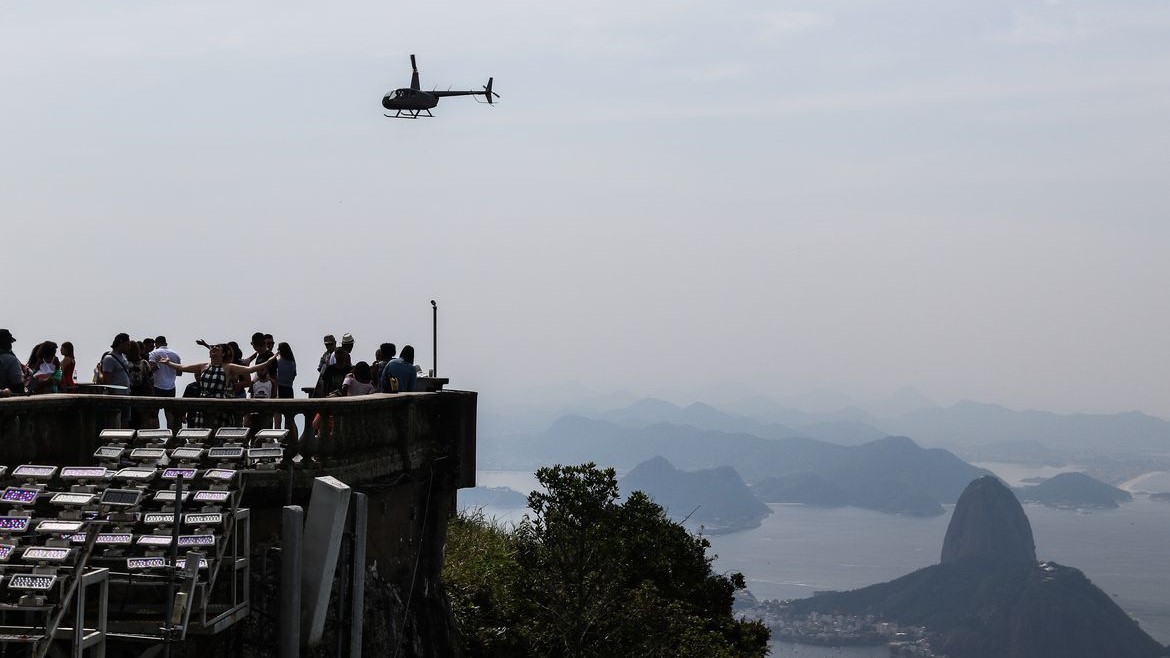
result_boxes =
[619,457,772,535]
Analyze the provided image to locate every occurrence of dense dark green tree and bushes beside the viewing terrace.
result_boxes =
[443,464,769,658]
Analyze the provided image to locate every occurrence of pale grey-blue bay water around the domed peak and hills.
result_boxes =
[467,464,1170,658]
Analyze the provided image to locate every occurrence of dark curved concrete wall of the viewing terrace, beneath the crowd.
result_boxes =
[0,390,477,656]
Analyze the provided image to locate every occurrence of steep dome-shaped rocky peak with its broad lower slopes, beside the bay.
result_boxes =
[793,478,1168,658]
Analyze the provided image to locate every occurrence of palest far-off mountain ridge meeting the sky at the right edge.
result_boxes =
[882,400,1170,453]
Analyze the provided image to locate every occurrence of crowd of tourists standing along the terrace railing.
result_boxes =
[0,329,420,427]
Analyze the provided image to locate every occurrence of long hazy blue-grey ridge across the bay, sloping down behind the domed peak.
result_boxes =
[527,416,986,515]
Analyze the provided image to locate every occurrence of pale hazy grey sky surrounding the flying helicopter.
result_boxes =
[0,0,1170,416]
